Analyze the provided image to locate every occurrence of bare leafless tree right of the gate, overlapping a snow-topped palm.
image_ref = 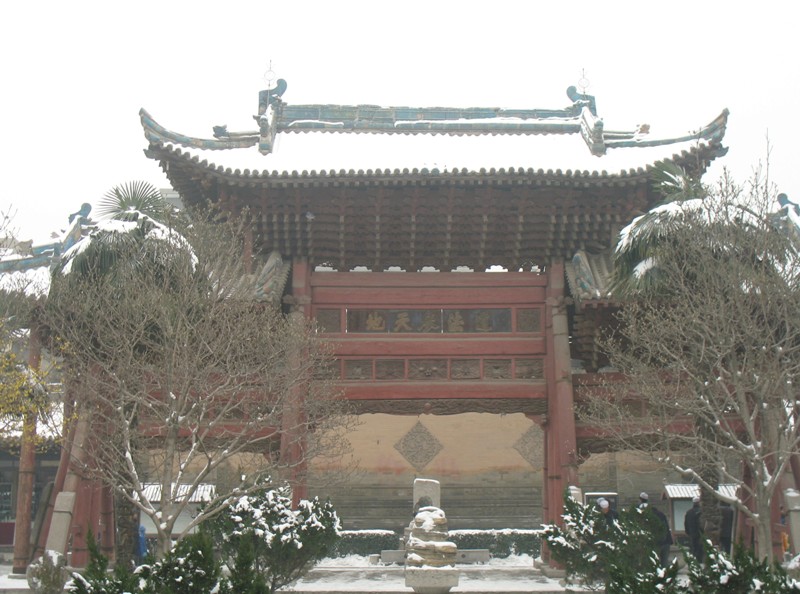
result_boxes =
[582,168,800,559]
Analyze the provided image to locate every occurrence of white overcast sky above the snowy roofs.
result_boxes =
[0,0,800,243]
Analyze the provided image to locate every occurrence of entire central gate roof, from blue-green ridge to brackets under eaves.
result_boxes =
[140,84,728,271]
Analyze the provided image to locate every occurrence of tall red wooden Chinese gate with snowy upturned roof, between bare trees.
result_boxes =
[140,81,727,529]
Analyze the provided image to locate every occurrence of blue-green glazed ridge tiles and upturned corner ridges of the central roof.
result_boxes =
[139,78,728,156]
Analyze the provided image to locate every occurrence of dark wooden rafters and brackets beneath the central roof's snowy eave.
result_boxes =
[150,138,715,271]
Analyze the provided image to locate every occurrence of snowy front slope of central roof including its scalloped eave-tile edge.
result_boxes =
[144,128,724,181]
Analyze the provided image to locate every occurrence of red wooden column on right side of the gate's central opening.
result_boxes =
[542,262,578,523]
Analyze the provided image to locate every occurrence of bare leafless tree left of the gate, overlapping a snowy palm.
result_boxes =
[47,199,349,554]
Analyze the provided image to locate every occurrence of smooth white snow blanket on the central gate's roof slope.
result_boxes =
[166,132,708,180]
